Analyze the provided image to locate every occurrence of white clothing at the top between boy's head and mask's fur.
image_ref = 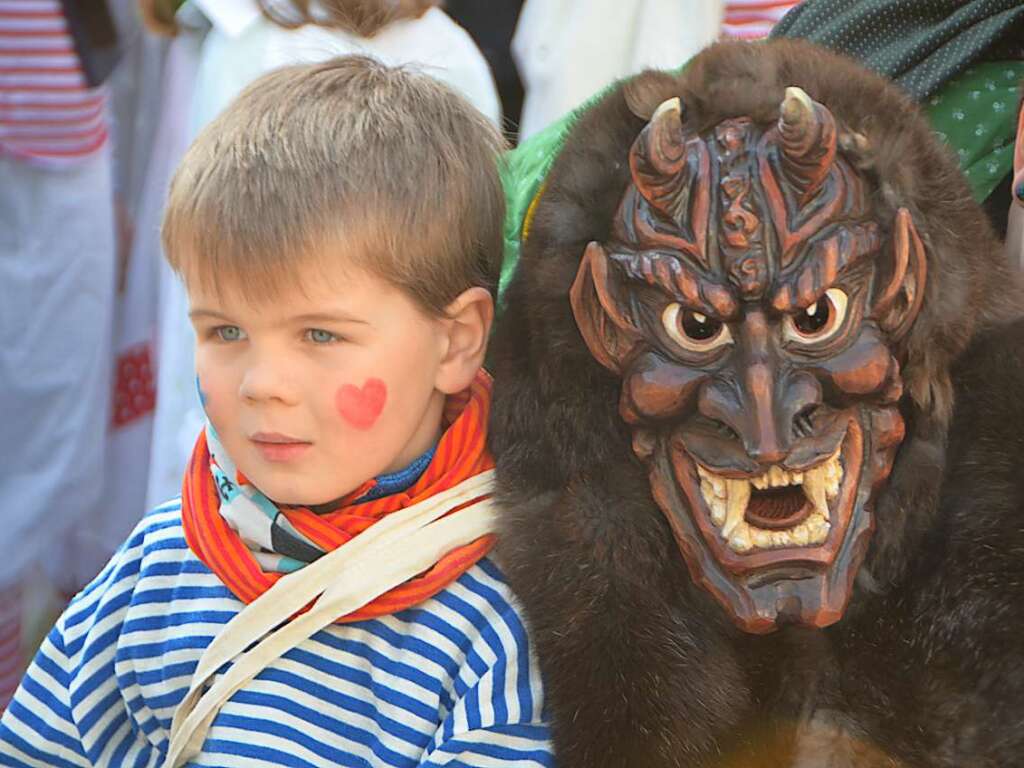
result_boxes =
[512,0,723,140]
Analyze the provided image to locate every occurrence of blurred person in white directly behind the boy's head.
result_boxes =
[141,0,501,514]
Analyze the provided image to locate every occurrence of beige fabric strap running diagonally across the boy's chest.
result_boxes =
[164,471,496,768]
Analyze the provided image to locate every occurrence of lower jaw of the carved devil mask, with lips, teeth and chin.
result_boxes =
[650,412,874,634]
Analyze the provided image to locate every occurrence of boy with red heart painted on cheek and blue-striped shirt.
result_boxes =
[0,57,551,767]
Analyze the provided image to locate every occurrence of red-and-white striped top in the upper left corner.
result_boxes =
[0,0,106,165]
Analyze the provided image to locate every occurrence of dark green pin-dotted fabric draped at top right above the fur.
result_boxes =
[771,0,1024,101]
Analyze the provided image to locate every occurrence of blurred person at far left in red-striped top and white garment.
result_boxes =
[0,0,117,709]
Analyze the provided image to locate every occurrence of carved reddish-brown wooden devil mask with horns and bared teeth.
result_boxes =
[571,88,926,633]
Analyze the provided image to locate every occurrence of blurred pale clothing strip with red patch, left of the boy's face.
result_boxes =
[44,0,178,594]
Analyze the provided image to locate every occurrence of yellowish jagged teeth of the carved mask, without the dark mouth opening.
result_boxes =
[697,449,843,554]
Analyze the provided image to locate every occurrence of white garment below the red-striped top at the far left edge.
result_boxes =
[0,147,116,587]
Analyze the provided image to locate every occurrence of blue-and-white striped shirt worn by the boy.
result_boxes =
[0,502,553,768]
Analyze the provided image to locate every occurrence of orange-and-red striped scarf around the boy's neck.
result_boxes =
[181,371,495,622]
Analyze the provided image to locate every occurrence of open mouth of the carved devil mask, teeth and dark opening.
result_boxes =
[696,445,844,554]
